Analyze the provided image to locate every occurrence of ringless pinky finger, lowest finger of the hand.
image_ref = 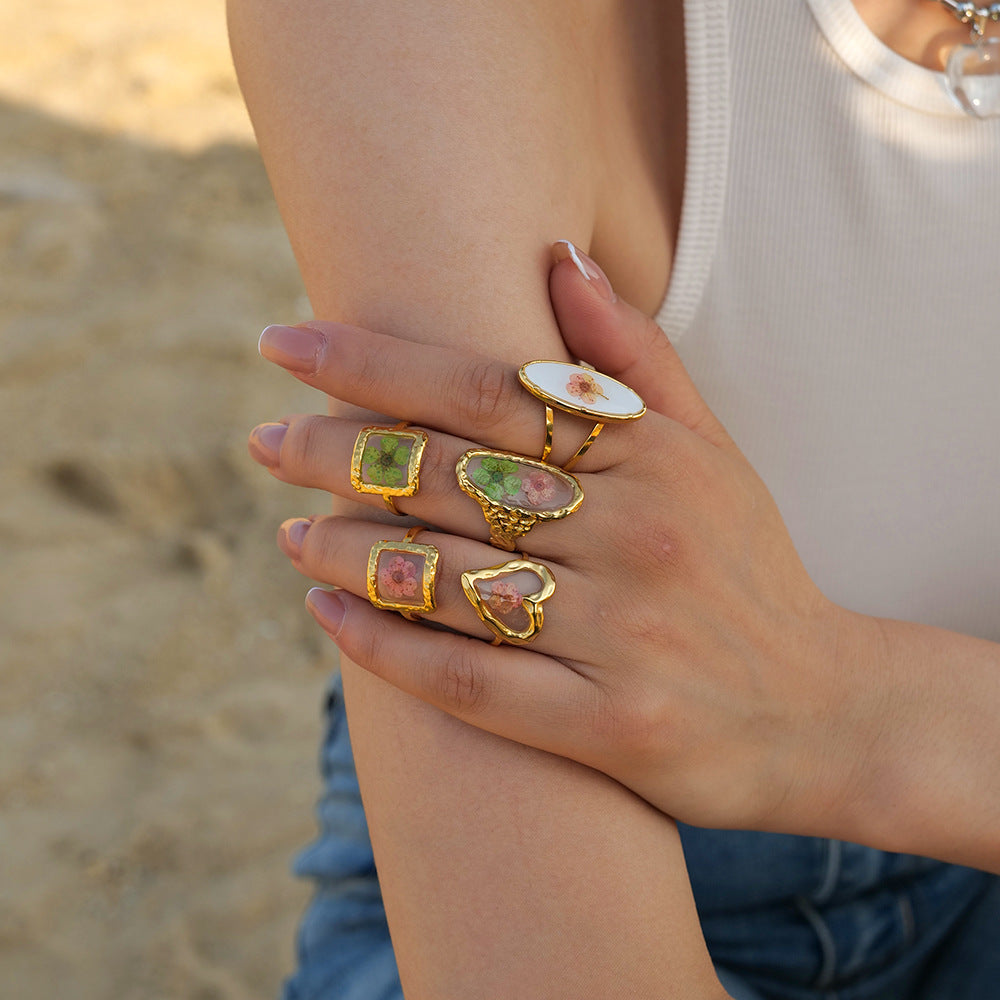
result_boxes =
[306,587,603,764]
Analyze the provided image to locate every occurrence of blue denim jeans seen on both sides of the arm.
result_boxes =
[283,678,1000,1000]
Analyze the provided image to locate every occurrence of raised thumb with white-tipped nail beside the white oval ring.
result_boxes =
[549,240,735,449]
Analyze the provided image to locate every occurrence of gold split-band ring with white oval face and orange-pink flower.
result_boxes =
[517,361,646,472]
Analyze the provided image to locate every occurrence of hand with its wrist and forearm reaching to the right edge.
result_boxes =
[252,262,1000,871]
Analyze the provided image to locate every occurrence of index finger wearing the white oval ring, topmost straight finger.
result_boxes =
[260,320,627,470]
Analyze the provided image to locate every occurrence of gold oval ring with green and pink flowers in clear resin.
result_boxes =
[455,448,583,552]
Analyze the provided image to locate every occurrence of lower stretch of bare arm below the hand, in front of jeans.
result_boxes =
[345,667,719,1000]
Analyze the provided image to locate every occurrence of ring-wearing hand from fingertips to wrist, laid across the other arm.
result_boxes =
[251,248,863,834]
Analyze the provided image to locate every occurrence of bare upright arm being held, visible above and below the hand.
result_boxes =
[231,2,719,1000]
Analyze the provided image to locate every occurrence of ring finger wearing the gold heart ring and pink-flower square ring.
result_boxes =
[278,516,602,656]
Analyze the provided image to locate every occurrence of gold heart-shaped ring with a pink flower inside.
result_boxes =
[462,557,556,646]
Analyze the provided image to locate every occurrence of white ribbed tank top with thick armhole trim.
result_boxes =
[658,0,1000,640]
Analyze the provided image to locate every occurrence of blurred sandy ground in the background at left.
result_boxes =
[0,0,335,1000]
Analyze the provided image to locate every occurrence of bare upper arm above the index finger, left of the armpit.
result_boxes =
[230,0,604,361]
